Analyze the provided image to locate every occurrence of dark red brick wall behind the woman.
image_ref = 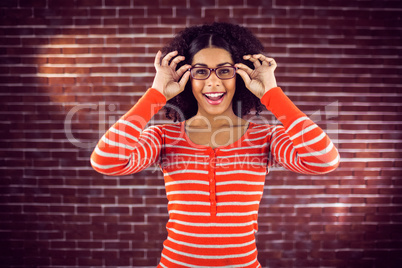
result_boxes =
[0,0,402,268]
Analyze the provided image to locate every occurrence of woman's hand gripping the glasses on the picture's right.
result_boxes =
[235,54,277,99]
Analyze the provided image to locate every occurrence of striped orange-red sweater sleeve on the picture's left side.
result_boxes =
[91,88,166,175]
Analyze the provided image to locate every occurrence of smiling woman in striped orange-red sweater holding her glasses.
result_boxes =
[91,23,339,267]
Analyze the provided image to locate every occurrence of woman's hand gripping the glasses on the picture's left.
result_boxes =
[152,51,191,100]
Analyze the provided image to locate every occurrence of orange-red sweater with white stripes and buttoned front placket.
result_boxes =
[91,88,339,268]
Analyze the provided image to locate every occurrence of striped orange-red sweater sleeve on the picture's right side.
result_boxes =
[261,87,340,174]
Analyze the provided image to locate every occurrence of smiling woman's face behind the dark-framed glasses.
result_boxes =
[191,48,236,116]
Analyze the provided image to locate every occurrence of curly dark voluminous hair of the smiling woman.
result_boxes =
[162,22,264,122]
